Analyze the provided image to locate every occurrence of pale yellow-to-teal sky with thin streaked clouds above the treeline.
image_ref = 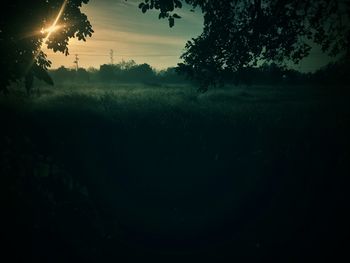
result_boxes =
[44,0,329,72]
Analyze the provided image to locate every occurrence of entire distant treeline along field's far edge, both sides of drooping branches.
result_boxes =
[50,60,350,86]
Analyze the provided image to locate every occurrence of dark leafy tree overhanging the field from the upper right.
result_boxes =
[139,0,350,86]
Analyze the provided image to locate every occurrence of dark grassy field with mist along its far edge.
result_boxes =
[0,84,350,262]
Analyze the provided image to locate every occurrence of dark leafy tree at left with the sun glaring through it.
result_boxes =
[0,0,93,92]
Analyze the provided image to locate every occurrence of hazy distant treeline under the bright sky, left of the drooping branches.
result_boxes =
[50,60,188,85]
